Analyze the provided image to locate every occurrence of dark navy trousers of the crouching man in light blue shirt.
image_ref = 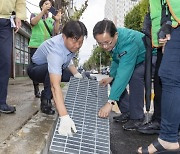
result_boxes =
[27,64,73,99]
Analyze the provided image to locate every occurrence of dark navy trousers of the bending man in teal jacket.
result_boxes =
[118,56,157,119]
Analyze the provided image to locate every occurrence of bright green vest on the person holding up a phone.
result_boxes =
[29,17,54,48]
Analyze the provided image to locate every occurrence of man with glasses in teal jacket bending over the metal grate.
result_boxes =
[93,20,155,130]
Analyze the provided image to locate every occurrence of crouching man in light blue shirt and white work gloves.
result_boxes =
[27,21,87,135]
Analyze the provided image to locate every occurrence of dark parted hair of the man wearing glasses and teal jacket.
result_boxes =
[93,19,117,38]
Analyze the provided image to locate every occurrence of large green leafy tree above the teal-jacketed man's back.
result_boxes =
[124,0,149,31]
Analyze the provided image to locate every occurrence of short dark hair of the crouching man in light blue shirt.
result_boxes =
[62,20,87,40]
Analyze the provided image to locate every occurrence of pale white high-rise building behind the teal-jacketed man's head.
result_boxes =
[105,0,140,27]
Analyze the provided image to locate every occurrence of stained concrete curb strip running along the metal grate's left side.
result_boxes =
[0,112,57,154]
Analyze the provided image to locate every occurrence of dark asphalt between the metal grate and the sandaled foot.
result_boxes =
[110,113,157,154]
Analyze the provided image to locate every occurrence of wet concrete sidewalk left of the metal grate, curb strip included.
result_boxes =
[0,78,66,154]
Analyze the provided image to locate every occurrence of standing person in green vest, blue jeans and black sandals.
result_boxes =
[138,0,180,154]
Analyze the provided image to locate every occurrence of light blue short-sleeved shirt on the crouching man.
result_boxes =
[32,34,75,75]
